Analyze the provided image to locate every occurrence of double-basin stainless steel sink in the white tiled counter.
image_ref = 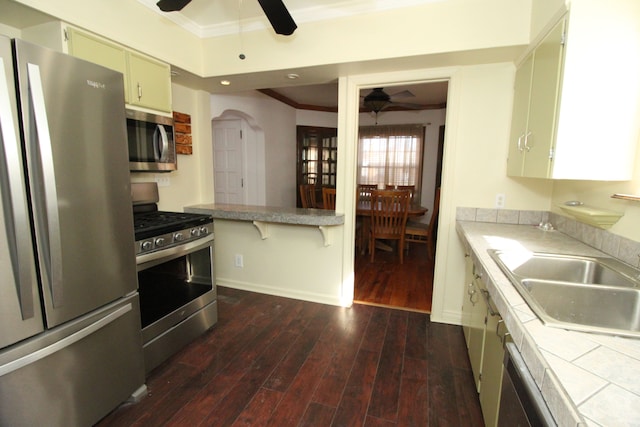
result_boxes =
[489,250,640,337]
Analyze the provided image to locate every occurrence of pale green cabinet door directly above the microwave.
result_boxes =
[127,52,171,112]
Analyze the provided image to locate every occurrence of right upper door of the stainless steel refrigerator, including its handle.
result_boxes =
[14,40,137,327]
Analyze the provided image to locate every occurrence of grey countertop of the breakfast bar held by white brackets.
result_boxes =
[184,203,344,227]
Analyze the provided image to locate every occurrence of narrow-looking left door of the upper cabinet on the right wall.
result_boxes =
[507,54,533,176]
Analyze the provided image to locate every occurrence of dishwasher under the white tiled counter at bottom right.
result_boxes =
[498,342,557,427]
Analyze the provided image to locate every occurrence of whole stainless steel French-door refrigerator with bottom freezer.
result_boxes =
[0,37,144,426]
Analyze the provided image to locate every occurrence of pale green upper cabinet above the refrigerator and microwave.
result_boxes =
[23,22,171,113]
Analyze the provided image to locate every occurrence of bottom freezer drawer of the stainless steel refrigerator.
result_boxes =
[0,294,144,427]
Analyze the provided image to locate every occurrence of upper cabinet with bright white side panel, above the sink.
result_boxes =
[507,0,640,181]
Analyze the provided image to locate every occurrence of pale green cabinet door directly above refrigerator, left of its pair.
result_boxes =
[68,27,129,102]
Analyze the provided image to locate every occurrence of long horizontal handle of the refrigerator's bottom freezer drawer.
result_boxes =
[0,303,133,377]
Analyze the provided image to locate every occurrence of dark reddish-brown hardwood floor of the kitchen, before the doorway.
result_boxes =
[98,287,482,427]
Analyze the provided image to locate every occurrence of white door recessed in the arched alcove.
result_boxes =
[213,120,246,204]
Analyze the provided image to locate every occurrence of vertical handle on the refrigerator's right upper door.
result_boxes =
[27,63,63,307]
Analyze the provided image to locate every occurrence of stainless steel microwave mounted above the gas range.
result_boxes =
[126,109,178,172]
